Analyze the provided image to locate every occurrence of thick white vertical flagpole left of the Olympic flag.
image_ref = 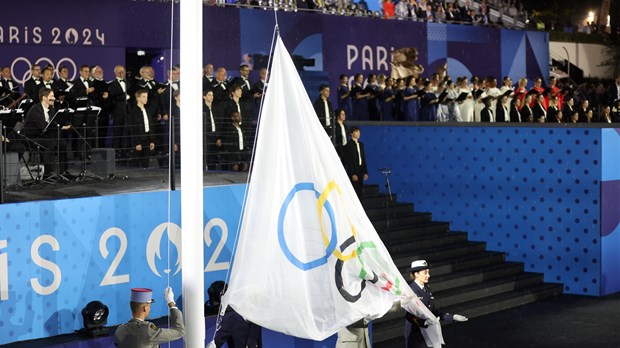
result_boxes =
[179,0,205,348]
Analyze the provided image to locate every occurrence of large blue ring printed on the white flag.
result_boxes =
[278,182,337,271]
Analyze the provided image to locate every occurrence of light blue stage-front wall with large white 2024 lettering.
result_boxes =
[0,185,245,344]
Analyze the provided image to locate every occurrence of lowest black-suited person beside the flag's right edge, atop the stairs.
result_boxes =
[343,126,368,200]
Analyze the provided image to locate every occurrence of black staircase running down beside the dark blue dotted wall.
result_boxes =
[363,185,563,348]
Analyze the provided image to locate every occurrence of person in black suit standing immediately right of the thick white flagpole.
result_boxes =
[202,90,225,170]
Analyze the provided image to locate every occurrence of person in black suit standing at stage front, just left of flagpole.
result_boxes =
[129,89,156,168]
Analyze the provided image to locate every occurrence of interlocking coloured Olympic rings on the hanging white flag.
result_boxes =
[277,181,401,302]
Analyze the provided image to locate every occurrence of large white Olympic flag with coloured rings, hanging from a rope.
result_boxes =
[222,37,441,346]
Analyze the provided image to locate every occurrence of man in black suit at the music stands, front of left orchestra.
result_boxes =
[24,88,71,175]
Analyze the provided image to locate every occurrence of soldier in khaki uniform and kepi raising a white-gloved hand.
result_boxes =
[114,287,185,348]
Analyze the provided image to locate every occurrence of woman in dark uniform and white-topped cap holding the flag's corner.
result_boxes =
[405,260,467,348]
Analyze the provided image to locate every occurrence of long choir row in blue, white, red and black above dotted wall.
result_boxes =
[337,69,620,123]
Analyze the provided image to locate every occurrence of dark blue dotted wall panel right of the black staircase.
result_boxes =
[362,125,620,296]
